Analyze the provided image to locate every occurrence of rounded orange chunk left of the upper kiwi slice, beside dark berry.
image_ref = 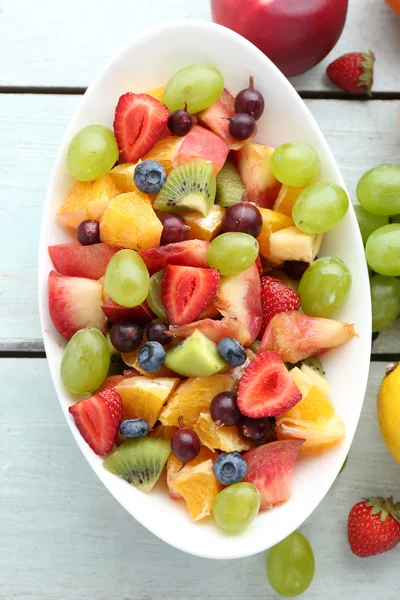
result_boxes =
[100,192,163,250]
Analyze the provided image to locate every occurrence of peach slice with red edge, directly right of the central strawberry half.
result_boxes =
[216,264,262,346]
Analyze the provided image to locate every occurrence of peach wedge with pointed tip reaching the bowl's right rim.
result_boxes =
[258,310,357,363]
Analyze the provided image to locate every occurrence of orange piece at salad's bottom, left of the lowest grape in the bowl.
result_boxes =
[167,460,221,521]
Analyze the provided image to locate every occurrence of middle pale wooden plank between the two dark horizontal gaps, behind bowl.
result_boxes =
[0,95,400,353]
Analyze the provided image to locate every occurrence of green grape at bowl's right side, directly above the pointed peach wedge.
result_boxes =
[299,256,351,318]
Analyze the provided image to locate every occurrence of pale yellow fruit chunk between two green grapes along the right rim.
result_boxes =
[270,226,323,263]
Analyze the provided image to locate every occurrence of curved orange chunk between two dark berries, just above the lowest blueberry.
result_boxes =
[194,412,251,452]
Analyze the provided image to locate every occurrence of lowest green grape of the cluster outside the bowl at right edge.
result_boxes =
[370,275,400,332]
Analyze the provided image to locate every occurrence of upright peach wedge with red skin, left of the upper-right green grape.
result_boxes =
[234,142,281,208]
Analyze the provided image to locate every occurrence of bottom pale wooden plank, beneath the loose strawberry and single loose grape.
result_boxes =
[0,359,400,600]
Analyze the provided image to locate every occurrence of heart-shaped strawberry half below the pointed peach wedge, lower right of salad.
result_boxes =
[237,352,302,419]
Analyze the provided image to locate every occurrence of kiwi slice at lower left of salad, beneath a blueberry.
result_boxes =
[103,437,171,494]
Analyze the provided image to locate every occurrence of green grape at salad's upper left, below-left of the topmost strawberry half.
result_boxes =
[68,125,119,181]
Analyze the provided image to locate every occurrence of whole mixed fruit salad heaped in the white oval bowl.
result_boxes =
[48,64,356,534]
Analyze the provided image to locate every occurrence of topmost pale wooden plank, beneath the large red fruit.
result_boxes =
[0,0,400,92]
